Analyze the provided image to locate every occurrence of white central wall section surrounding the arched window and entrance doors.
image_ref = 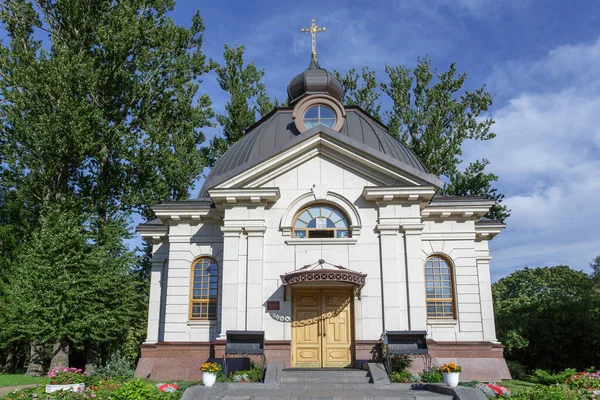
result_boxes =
[255,157,382,340]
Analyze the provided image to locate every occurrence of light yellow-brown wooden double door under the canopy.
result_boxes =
[292,289,354,368]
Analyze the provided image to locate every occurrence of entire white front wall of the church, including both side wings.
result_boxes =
[151,152,495,342]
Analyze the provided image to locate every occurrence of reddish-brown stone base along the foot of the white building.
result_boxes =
[136,340,510,382]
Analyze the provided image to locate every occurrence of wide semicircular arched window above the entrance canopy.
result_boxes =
[292,204,350,239]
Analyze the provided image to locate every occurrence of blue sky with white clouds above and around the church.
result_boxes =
[0,0,600,279]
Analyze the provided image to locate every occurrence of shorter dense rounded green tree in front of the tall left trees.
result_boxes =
[7,205,137,365]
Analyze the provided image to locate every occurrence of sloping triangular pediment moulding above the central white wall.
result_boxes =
[205,125,442,192]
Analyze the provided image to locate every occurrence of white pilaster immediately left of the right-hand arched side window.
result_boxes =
[402,224,427,331]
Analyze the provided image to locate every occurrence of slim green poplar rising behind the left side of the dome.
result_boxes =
[203,44,278,166]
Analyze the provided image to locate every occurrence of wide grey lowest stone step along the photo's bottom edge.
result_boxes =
[182,383,452,400]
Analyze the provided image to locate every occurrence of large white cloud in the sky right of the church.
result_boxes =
[467,39,600,278]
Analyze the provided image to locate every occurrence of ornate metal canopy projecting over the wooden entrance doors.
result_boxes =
[280,259,367,301]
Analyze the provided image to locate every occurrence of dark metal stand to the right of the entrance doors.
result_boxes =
[382,331,431,373]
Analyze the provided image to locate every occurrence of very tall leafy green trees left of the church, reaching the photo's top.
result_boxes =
[0,0,213,370]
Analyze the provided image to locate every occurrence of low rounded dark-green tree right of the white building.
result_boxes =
[492,265,600,371]
